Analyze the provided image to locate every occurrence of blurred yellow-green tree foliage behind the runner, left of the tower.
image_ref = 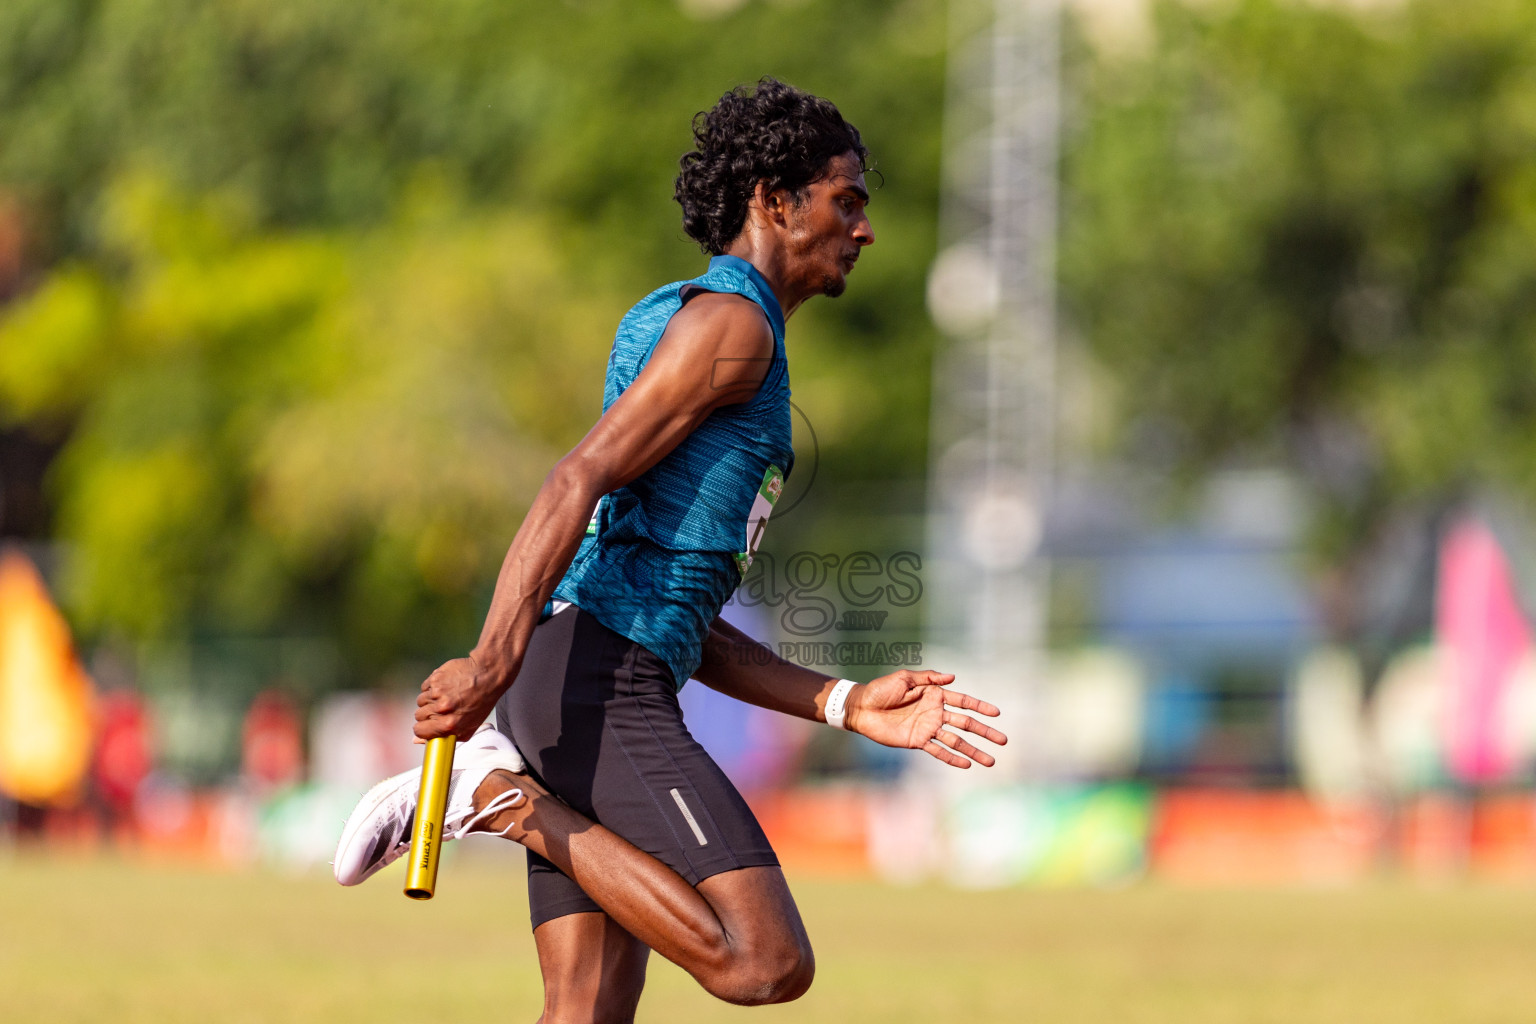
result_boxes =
[0,0,945,680]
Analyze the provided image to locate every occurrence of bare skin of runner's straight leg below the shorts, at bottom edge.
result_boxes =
[533,912,651,1024]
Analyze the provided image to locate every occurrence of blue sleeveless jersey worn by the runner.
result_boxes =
[554,256,794,686]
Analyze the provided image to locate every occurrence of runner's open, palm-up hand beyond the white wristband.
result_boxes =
[845,669,1008,768]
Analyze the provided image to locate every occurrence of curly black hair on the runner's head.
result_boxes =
[673,78,869,256]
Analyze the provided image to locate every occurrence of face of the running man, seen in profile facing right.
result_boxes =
[786,150,874,298]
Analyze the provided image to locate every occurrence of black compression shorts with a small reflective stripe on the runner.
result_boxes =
[496,605,779,927]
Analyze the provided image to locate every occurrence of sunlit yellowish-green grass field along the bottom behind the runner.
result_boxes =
[0,851,1536,1024]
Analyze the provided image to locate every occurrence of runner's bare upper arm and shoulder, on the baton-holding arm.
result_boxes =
[565,292,773,493]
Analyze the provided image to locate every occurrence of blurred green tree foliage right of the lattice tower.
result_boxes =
[1061,0,1536,633]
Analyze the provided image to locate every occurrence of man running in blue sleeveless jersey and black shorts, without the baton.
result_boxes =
[336,78,1006,1024]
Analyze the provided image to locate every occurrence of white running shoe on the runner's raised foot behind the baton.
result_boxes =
[332,729,527,886]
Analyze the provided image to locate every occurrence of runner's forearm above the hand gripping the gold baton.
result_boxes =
[470,459,604,689]
